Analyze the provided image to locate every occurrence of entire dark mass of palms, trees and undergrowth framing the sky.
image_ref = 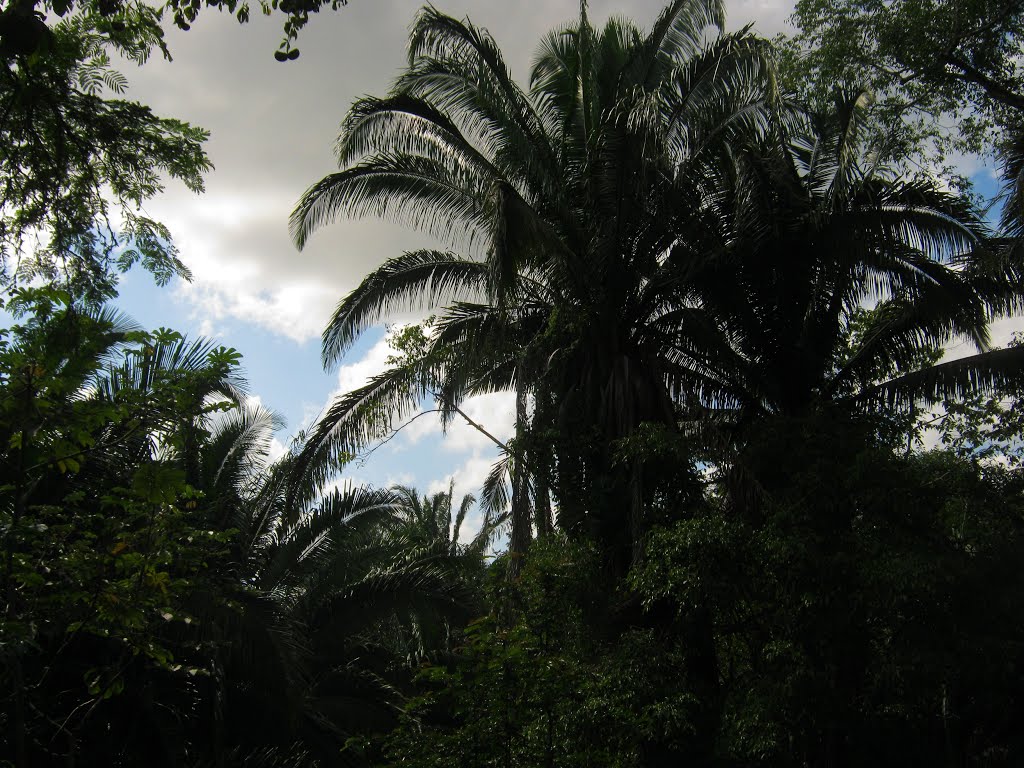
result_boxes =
[6,0,1024,768]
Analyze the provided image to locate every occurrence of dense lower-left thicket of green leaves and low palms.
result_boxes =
[0,290,481,766]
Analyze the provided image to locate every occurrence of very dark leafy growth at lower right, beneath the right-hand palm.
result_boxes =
[631,434,1024,766]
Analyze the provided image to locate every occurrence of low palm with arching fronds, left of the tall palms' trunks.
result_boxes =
[185,406,482,758]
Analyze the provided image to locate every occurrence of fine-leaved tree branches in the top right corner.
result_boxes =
[792,0,1024,173]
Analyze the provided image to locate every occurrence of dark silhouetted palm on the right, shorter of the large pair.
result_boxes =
[659,96,1024,456]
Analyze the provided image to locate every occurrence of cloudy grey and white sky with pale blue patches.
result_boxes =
[108,0,1011,531]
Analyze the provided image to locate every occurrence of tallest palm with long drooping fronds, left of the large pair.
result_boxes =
[292,0,770,565]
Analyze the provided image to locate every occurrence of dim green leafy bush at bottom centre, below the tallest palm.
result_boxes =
[385,536,649,767]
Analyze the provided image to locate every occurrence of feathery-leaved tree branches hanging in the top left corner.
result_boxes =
[0,0,360,296]
